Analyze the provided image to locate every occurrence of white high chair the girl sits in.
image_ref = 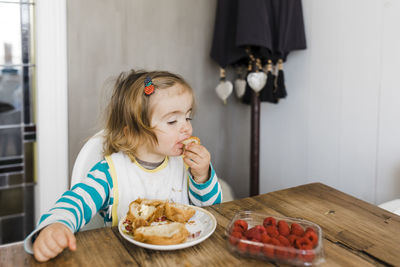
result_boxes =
[71,130,234,231]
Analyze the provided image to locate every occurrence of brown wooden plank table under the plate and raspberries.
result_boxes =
[0,183,400,267]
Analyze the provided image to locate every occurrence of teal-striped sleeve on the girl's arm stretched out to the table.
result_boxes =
[24,160,113,254]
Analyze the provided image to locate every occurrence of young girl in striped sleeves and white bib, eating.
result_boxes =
[25,70,222,261]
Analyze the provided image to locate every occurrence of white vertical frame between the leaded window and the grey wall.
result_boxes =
[35,0,68,220]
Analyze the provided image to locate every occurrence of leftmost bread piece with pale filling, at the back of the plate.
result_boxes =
[126,198,165,229]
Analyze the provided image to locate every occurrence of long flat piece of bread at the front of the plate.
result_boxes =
[133,222,189,245]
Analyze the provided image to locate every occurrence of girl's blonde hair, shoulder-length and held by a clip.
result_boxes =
[103,70,194,156]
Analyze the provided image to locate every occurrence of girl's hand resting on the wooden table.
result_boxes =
[33,223,76,262]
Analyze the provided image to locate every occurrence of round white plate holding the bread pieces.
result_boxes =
[118,206,217,250]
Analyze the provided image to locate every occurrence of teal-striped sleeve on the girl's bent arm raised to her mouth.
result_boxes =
[188,163,222,206]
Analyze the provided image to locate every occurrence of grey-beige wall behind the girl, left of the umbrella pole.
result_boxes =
[67,0,250,197]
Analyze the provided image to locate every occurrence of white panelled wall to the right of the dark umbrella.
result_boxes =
[261,0,400,203]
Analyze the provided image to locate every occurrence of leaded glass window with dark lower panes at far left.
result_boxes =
[0,0,36,244]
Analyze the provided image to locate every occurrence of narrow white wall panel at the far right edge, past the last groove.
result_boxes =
[376,0,400,204]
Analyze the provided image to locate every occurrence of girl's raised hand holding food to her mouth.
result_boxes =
[183,143,211,184]
